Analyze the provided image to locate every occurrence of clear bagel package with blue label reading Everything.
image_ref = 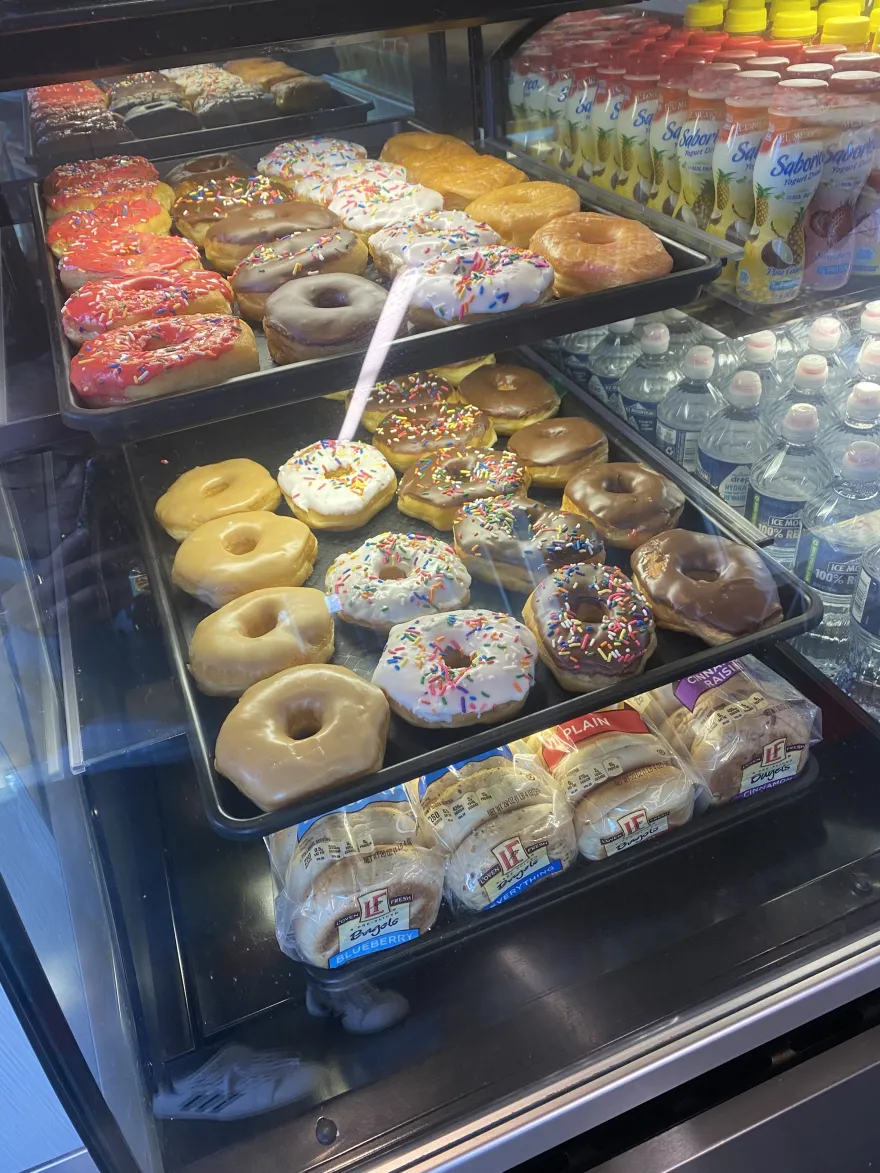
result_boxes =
[408,743,577,911]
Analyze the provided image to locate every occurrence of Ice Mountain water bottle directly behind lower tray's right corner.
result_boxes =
[745,404,834,569]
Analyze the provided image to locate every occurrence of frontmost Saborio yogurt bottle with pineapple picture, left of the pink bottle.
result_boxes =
[737,77,828,305]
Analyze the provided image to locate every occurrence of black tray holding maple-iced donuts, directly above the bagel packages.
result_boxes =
[120,354,821,839]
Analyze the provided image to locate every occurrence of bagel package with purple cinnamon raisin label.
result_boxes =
[628,656,821,806]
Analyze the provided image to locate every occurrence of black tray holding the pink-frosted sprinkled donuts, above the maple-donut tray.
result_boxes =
[31,121,720,443]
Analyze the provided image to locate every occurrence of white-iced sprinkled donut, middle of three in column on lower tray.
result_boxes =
[324,534,471,632]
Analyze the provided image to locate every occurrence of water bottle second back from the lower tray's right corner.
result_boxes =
[697,371,761,513]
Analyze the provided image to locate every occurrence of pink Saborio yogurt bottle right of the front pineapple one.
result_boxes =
[804,124,875,291]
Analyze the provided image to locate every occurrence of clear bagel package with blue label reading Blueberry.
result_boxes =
[268,786,445,969]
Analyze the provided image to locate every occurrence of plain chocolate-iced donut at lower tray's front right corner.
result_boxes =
[631,529,783,644]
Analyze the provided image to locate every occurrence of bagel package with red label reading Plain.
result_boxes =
[530,705,695,860]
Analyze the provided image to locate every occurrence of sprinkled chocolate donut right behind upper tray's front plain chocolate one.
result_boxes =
[230,228,368,320]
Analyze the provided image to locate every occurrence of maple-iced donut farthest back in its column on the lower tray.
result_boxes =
[155,456,282,542]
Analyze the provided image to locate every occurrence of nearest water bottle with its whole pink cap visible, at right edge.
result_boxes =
[794,440,880,673]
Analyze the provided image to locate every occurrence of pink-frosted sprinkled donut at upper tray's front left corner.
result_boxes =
[70,313,259,407]
